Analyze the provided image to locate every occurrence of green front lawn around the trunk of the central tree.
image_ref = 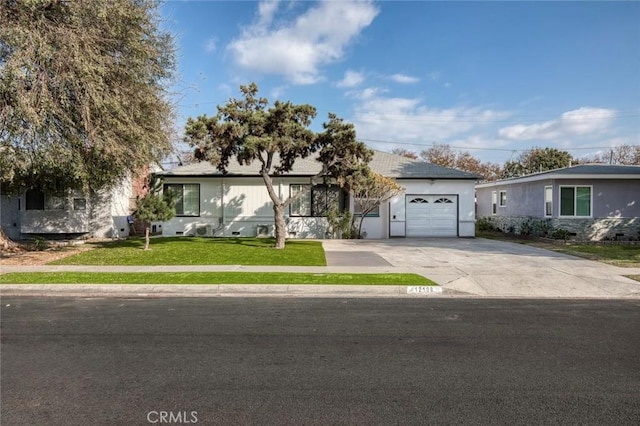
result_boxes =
[50,237,327,266]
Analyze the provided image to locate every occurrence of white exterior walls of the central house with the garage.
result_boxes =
[162,176,475,239]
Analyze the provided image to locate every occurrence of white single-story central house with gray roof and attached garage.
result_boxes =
[156,151,478,238]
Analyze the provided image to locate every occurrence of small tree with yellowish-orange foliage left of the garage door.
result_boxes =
[348,167,404,238]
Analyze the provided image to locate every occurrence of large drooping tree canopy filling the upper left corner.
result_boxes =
[0,0,175,191]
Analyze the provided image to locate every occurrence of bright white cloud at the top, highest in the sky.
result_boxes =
[227,0,379,84]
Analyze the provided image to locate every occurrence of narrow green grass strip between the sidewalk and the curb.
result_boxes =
[0,272,437,286]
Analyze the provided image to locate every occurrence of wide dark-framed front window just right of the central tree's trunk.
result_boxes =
[289,184,344,217]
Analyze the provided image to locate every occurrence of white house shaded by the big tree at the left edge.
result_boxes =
[0,172,146,240]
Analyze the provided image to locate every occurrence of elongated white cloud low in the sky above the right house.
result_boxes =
[498,107,616,141]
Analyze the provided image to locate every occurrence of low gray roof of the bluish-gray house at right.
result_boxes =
[477,164,640,188]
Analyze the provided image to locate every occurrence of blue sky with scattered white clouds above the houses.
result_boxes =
[161,1,640,163]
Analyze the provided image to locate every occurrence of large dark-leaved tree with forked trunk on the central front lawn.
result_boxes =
[185,83,372,249]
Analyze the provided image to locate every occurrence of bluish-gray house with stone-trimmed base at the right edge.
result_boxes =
[476,164,640,240]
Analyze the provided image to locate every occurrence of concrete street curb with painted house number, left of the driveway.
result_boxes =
[0,284,443,298]
